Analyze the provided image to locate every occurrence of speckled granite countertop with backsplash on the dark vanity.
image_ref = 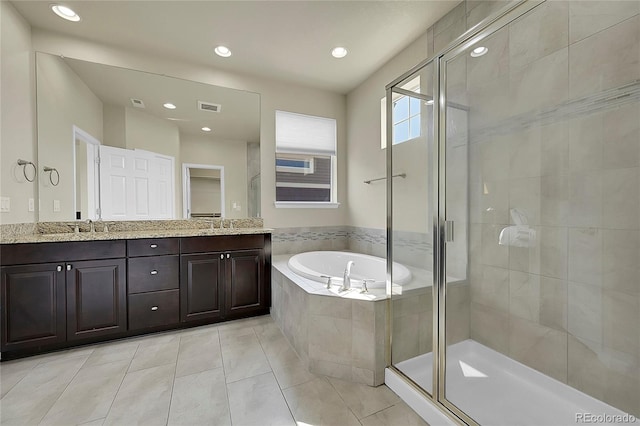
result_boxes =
[0,219,273,244]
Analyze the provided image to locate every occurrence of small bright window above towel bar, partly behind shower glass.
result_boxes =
[380,76,421,149]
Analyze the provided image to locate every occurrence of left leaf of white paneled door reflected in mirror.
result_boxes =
[100,145,132,220]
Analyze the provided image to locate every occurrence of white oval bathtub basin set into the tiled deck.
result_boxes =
[288,251,411,288]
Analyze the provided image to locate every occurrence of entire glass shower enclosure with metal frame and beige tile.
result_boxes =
[386,1,640,425]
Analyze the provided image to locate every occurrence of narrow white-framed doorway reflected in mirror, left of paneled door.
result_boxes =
[73,126,100,220]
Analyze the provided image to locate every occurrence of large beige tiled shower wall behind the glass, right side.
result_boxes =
[464,1,640,415]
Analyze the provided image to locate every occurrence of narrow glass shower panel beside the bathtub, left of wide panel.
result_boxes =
[386,60,435,394]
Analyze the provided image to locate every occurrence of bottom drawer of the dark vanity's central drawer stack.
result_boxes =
[129,290,180,330]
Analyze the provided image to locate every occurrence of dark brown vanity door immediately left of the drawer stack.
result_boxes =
[66,259,127,340]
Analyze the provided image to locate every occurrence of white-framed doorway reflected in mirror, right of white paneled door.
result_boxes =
[182,164,225,219]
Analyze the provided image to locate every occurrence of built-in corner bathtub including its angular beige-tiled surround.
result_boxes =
[271,252,432,386]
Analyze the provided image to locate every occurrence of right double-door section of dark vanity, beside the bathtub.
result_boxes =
[180,234,270,322]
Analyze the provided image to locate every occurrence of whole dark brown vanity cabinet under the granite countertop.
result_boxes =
[0,234,271,359]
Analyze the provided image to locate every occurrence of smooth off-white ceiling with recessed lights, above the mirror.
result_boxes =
[12,0,459,93]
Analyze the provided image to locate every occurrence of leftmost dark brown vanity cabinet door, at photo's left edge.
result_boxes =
[0,263,66,352]
